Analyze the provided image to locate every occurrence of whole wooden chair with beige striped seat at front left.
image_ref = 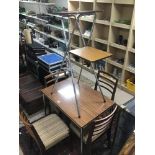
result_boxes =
[19,107,69,155]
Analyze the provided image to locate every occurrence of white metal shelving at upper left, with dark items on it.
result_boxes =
[19,0,69,55]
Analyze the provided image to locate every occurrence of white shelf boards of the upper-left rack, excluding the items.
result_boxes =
[19,0,69,56]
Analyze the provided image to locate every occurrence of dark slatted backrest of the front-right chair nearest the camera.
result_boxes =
[87,104,117,143]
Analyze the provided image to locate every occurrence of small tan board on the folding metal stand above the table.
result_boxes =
[70,46,112,62]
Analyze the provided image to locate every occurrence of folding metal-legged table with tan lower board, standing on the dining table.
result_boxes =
[47,11,111,118]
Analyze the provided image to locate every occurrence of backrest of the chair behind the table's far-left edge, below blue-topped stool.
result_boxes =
[44,71,69,87]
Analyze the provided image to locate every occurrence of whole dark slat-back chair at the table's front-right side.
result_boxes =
[70,104,117,155]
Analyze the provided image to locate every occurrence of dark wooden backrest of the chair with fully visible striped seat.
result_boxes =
[19,108,45,150]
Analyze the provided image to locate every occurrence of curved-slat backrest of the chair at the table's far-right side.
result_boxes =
[94,70,118,100]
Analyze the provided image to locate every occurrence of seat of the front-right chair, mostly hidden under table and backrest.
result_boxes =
[70,123,102,144]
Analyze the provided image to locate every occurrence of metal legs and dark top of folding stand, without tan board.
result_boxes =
[48,11,105,114]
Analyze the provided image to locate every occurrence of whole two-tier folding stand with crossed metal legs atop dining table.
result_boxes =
[50,11,112,117]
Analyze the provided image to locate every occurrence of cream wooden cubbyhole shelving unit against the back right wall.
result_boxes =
[68,0,135,94]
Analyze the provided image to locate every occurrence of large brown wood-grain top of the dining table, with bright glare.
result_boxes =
[41,78,113,128]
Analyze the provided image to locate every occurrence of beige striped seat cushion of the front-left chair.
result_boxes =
[33,114,69,150]
